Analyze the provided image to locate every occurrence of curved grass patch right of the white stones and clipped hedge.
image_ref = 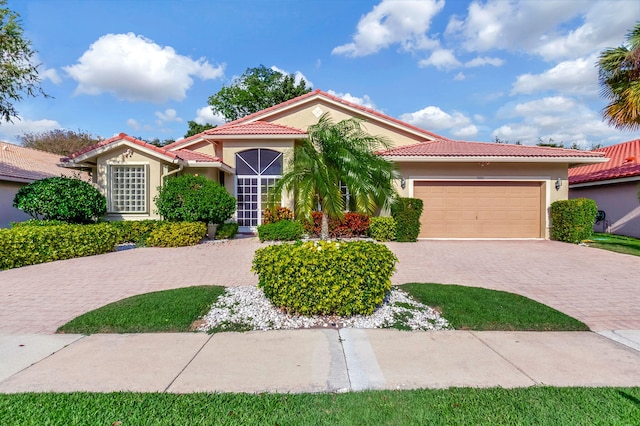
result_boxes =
[400,283,589,331]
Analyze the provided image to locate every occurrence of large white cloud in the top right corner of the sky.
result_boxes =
[445,0,640,61]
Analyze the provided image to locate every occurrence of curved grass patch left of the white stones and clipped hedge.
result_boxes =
[58,286,224,334]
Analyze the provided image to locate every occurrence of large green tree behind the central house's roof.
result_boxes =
[209,65,311,121]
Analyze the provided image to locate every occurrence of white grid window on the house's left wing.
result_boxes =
[109,165,147,213]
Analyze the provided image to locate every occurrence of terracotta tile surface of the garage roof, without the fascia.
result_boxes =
[379,139,604,158]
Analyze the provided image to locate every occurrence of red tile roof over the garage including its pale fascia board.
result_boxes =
[379,139,606,163]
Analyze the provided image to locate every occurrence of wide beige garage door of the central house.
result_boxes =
[413,181,542,238]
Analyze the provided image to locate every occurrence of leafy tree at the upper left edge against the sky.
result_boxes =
[0,0,47,122]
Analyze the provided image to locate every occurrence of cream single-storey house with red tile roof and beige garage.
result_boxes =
[62,90,607,238]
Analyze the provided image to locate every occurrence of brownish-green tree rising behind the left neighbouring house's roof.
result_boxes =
[18,129,102,156]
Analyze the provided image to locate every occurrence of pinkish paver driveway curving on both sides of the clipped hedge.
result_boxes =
[0,238,640,334]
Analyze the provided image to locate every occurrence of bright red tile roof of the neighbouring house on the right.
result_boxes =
[569,139,640,184]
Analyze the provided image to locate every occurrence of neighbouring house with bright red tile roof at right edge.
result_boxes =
[569,139,640,238]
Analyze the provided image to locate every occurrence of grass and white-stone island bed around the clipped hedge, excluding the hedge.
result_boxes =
[58,283,588,334]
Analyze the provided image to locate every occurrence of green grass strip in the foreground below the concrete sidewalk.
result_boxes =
[0,387,640,426]
